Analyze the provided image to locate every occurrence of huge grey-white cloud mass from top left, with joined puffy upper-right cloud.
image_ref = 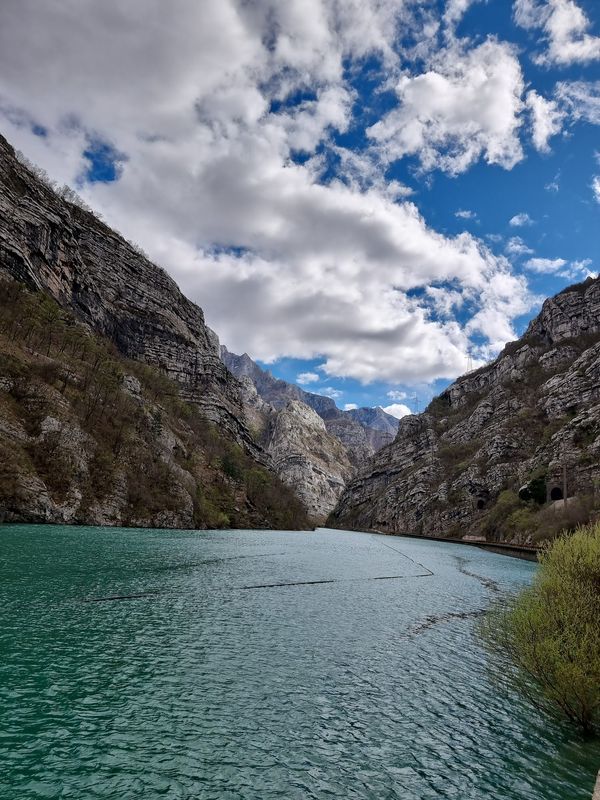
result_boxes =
[0,0,531,384]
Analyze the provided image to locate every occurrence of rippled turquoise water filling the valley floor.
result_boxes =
[0,526,600,800]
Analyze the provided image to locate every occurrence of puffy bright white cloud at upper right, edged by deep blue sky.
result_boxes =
[367,39,523,175]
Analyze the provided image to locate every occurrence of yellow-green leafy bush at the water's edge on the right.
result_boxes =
[482,523,600,734]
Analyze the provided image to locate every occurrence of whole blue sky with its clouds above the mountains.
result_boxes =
[0,0,600,416]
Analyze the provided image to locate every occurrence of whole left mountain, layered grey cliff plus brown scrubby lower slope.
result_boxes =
[0,136,307,527]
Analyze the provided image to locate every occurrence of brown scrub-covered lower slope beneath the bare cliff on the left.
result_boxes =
[0,279,307,528]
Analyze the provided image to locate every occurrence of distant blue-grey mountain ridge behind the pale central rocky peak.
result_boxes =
[221,345,398,467]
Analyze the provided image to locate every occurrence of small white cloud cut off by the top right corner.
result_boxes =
[514,0,600,66]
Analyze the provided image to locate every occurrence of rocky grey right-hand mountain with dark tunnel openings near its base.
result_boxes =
[330,278,600,543]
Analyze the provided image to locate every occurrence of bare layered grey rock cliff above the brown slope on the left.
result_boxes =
[0,136,265,461]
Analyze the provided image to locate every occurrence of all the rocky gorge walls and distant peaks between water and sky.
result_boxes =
[0,125,600,544]
